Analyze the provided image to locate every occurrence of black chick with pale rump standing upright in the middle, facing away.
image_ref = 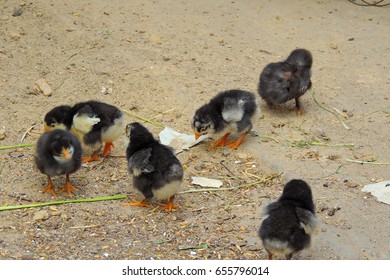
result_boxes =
[125,122,183,211]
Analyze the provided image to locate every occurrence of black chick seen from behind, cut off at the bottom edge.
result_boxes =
[258,180,319,260]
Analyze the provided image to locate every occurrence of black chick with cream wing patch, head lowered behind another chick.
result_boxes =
[44,100,125,162]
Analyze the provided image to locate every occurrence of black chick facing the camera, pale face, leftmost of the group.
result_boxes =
[35,129,82,197]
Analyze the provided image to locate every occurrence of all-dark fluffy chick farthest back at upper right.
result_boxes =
[258,49,313,116]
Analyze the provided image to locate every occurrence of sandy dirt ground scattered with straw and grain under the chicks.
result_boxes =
[0,0,390,259]
